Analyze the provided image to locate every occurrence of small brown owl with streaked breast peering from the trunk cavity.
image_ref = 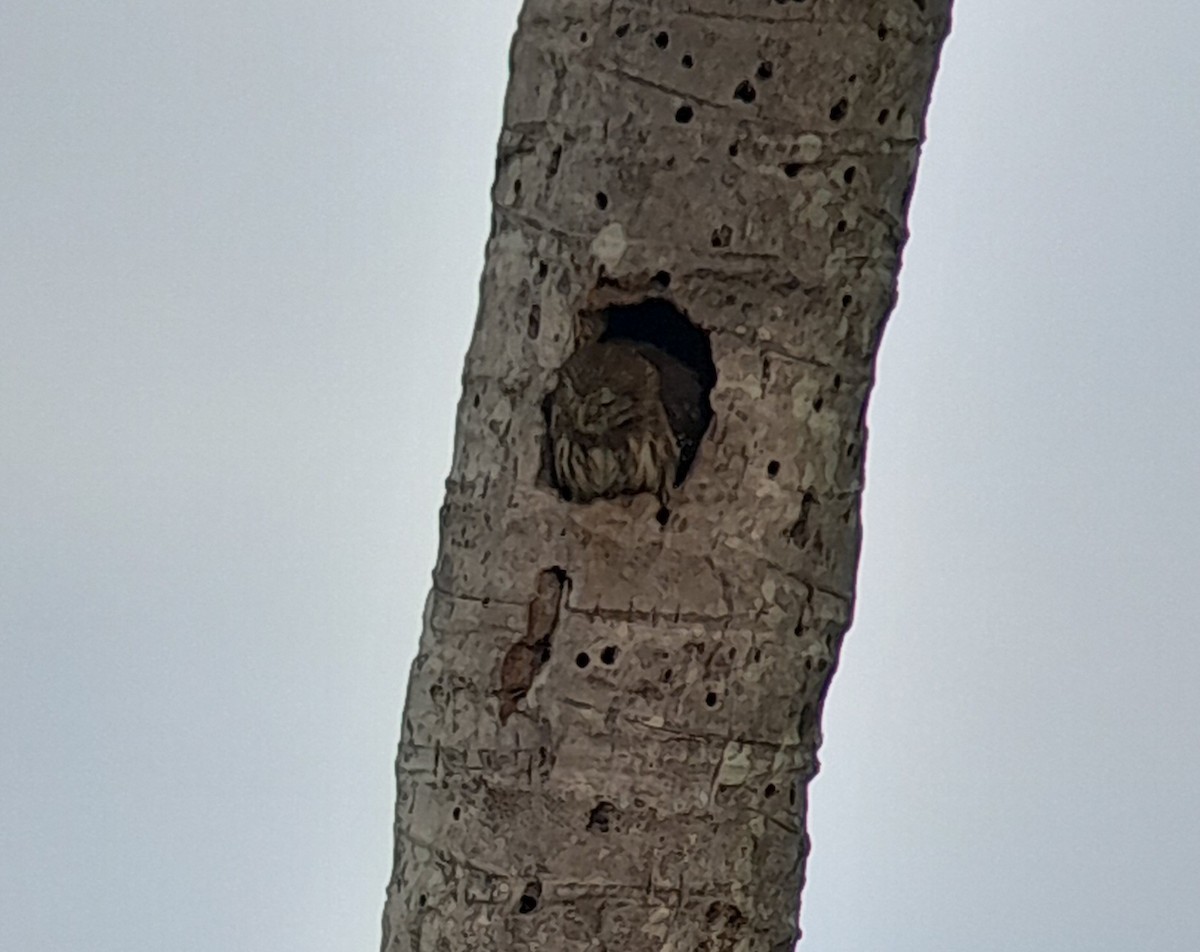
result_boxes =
[547,340,708,503]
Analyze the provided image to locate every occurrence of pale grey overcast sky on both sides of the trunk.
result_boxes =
[0,0,1200,952]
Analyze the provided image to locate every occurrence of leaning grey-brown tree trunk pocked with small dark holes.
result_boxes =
[383,0,949,952]
